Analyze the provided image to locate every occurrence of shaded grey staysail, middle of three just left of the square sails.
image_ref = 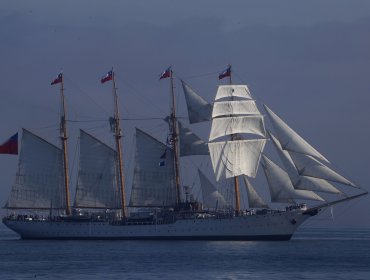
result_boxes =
[178,122,209,157]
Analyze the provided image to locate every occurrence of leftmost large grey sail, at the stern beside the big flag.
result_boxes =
[6,129,66,209]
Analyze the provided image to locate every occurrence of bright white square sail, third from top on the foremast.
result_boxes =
[209,115,265,141]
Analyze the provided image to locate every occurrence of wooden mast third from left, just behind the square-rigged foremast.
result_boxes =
[170,68,181,205]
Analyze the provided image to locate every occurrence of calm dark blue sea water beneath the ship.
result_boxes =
[0,225,370,280]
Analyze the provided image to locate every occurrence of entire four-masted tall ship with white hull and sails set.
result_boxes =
[0,65,367,240]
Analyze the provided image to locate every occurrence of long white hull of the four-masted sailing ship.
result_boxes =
[4,211,310,240]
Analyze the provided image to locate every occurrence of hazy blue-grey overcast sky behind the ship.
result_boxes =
[0,0,370,226]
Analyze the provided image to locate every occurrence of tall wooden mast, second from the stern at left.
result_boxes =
[112,68,126,218]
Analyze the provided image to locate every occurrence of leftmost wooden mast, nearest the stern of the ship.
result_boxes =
[59,73,71,215]
